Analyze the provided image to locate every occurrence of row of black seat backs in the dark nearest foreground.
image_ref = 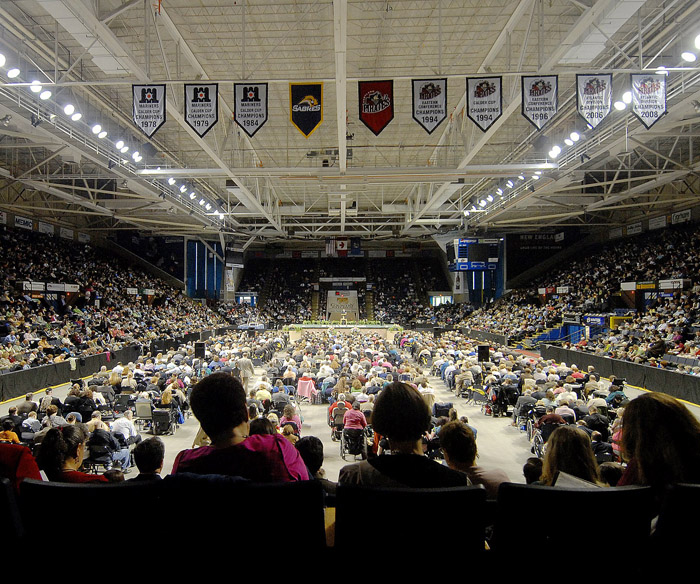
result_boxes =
[0,475,700,566]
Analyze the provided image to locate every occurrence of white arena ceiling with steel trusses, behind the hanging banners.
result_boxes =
[0,0,700,247]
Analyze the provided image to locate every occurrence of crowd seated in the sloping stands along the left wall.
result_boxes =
[0,229,225,371]
